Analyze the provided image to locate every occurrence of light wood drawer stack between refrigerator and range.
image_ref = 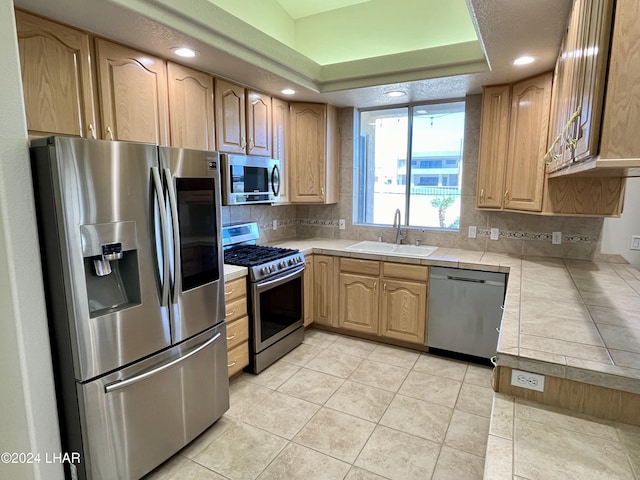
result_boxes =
[224,277,249,377]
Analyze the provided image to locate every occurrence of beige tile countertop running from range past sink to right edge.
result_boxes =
[273,238,640,394]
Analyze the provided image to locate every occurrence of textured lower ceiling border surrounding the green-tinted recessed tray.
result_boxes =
[14,0,572,107]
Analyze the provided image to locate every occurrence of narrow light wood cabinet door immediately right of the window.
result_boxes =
[476,85,511,209]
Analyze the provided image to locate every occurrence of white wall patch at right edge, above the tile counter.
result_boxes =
[600,178,640,269]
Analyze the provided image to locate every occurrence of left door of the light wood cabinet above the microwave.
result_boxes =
[215,78,245,156]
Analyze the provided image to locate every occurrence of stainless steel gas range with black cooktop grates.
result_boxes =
[222,222,304,373]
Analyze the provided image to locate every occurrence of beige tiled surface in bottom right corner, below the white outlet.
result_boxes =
[485,393,640,480]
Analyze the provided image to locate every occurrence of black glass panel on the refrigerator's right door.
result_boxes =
[176,178,220,291]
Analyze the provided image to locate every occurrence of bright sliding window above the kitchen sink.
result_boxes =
[355,101,464,229]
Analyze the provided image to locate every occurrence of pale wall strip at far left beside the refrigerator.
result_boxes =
[0,0,63,480]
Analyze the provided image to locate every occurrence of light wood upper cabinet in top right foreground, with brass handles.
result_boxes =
[547,0,640,177]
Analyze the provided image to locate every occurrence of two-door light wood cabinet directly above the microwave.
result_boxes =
[215,78,273,157]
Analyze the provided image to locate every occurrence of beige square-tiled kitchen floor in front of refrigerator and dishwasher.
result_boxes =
[145,329,493,480]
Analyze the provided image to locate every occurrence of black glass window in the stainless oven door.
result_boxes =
[260,277,302,342]
